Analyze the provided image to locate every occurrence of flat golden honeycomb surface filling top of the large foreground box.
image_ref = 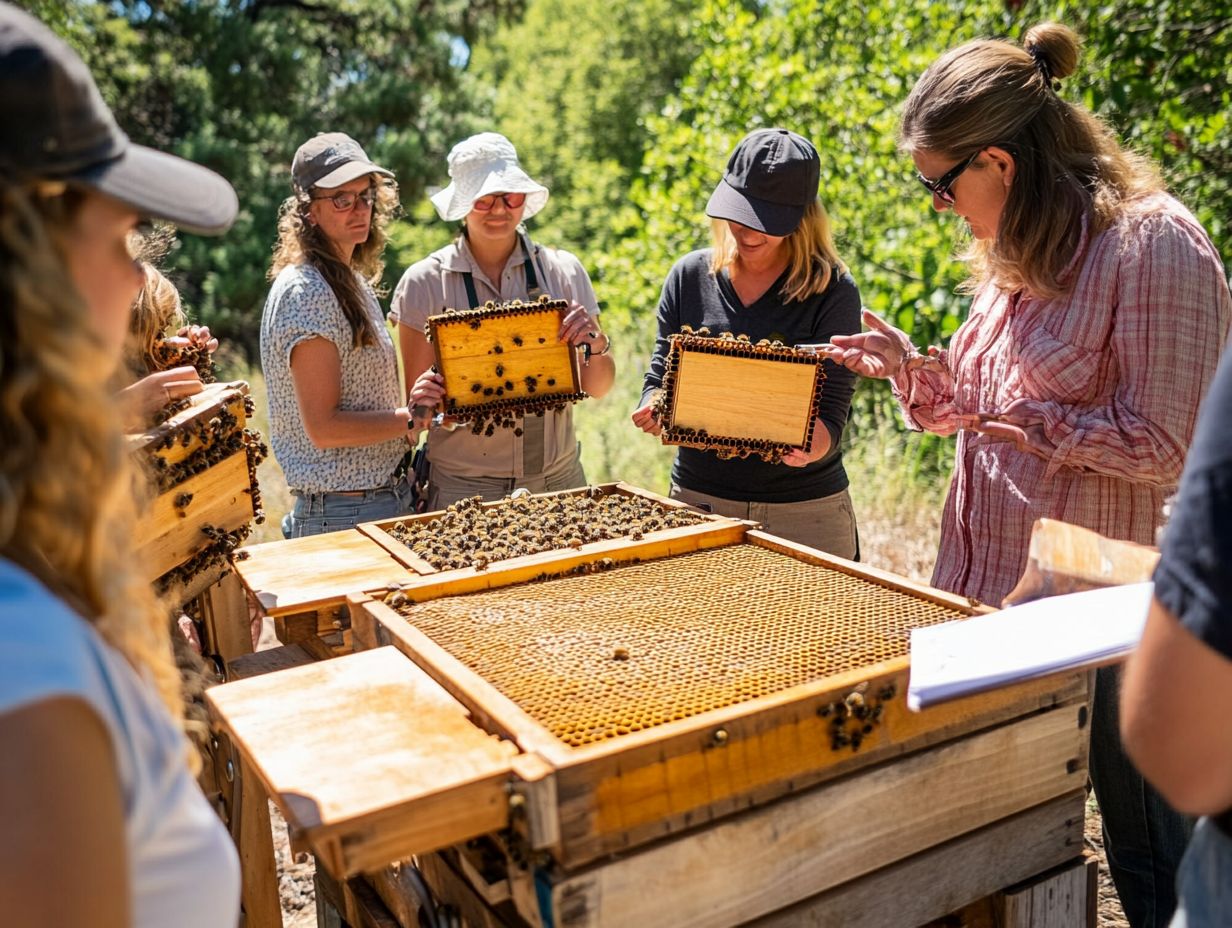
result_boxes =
[387,543,965,747]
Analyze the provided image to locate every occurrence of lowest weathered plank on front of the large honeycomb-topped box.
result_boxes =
[745,790,1094,928]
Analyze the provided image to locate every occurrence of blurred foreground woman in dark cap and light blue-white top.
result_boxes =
[0,2,239,928]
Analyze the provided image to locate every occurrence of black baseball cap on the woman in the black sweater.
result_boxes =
[706,128,822,235]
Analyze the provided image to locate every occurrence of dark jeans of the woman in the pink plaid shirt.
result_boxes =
[1090,667,1194,928]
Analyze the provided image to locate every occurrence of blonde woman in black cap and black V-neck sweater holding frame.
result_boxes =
[633,128,860,560]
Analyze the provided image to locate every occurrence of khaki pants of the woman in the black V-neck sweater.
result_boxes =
[671,483,860,561]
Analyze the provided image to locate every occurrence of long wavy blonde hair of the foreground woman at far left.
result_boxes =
[0,185,187,749]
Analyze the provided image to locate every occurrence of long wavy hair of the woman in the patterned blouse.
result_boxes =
[266,175,398,348]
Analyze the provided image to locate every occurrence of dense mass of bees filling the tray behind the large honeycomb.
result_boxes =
[389,487,705,571]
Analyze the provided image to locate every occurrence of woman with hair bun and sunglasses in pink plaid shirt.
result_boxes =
[829,23,1232,928]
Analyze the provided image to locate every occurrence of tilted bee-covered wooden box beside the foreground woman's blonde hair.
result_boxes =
[129,381,265,598]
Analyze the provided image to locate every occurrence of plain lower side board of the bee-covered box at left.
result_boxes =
[134,450,253,580]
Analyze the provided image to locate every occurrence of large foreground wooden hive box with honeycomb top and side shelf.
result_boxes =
[209,526,1088,928]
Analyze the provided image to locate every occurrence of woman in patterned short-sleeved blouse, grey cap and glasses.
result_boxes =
[261,132,420,539]
